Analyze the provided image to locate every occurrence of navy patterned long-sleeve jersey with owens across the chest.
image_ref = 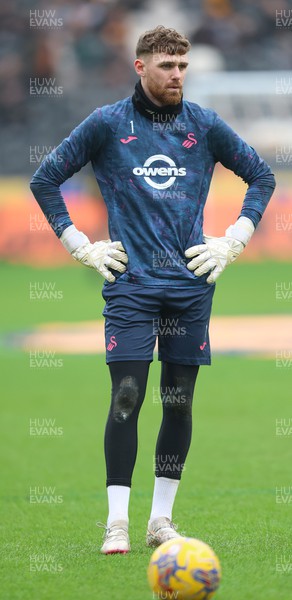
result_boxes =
[31,97,275,286]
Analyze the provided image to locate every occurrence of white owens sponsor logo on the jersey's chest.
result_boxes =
[133,154,186,190]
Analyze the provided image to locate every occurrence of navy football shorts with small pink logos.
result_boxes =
[102,282,215,365]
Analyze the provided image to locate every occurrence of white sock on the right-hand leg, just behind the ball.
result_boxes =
[149,477,179,521]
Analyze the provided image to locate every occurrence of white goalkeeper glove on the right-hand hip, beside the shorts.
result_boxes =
[185,217,255,283]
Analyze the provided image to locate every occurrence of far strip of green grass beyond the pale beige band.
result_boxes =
[0,261,292,331]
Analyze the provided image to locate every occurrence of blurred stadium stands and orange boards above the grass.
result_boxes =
[0,0,292,264]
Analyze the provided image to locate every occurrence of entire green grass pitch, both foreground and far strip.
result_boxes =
[0,264,292,600]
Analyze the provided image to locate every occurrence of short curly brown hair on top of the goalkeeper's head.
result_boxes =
[136,25,191,58]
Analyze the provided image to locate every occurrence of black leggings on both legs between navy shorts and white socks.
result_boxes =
[105,361,199,487]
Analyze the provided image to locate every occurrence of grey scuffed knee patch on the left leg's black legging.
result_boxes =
[112,375,139,423]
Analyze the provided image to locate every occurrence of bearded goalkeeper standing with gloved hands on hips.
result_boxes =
[31,26,275,554]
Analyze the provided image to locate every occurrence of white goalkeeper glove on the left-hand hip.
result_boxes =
[60,225,128,283]
